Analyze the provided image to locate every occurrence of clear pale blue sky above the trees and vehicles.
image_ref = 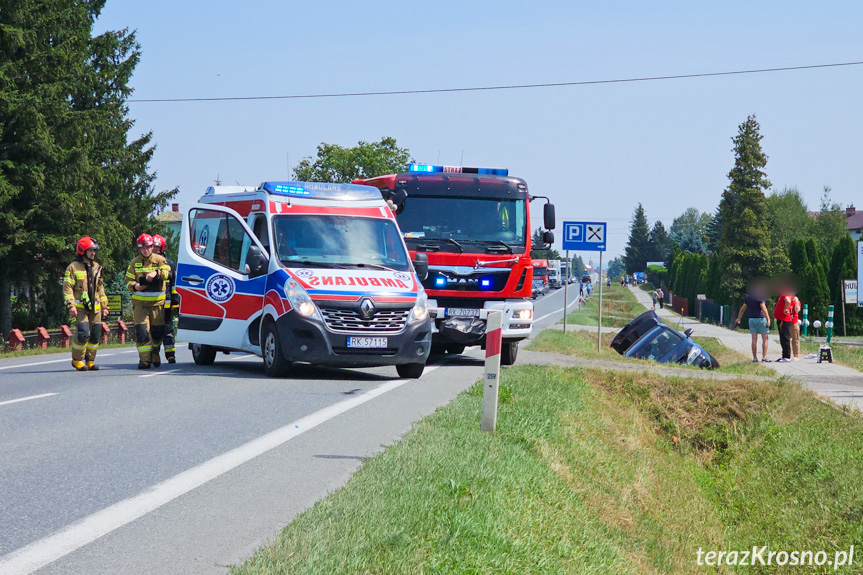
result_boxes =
[96,0,863,261]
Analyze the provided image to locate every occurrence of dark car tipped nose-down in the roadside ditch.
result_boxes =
[611,310,719,369]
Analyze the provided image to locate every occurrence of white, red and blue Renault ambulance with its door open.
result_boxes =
[176,182,431,378]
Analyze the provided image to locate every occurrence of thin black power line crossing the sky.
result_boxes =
[126,62,863,104]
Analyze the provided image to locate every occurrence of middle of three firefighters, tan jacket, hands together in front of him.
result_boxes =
[126,234,171,369]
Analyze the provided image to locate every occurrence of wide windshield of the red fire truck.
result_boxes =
[398,198,527,253]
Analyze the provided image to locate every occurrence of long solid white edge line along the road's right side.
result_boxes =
[0,365,440,575]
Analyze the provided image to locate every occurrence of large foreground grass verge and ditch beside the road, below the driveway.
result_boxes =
[231,366,863,575]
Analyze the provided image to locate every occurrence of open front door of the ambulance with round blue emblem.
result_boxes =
[177,204,269,354]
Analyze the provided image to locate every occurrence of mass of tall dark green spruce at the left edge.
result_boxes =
[0,0,177,333]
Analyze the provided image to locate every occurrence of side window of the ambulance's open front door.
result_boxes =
[189,209,251,271]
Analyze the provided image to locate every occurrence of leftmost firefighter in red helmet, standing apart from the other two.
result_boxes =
[63,236,108,371]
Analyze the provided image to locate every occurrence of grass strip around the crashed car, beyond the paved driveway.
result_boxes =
[527,329,776,377]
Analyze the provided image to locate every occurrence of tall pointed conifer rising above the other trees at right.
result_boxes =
[716,116,772,306]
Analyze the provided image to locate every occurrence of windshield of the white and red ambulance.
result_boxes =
[273,214,412,272]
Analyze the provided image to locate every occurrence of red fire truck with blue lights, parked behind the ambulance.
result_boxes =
[354,164,554,365]
